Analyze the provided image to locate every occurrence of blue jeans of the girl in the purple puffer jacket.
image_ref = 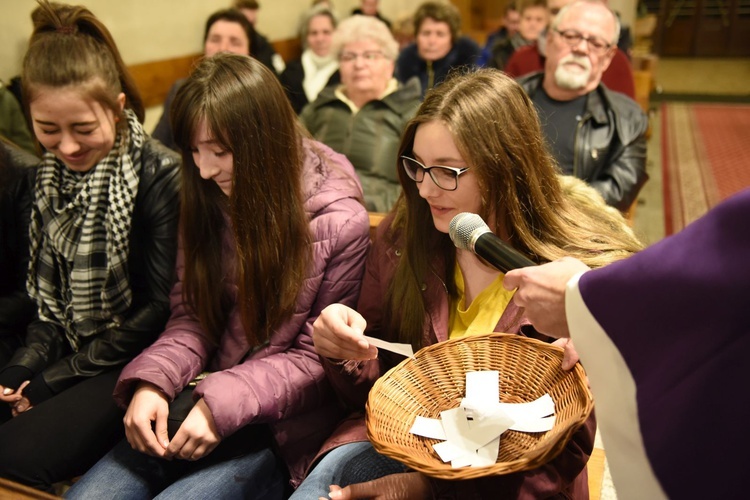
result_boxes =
[65,440,285,500]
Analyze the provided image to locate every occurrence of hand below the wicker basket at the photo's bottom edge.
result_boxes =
[320,472,431,500]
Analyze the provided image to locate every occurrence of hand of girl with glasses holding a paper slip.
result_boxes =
[313,304,378,359]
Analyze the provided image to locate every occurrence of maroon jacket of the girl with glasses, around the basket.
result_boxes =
[321,215,596,500]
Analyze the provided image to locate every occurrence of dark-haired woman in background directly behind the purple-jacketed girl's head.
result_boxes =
[151,9,276,151]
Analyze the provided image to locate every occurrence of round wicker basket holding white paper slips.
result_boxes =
[367,333,593,479]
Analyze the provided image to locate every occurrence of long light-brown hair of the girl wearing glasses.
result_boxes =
[385,70,641,345]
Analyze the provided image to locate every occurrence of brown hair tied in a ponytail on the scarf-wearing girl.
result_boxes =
[21,0,144,122]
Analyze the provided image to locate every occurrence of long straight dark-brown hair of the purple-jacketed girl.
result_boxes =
[170,54,312,345]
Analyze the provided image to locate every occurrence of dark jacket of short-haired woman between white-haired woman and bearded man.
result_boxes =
[396,36,480,97]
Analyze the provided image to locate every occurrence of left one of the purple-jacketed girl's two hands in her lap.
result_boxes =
[123,382,169,458]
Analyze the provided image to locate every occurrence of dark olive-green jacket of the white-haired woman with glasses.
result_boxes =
[300,78,421,212]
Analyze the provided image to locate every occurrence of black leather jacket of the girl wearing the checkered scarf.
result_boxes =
[0,138,180,404]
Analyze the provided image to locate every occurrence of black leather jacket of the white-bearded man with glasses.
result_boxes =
[519,72,648,212]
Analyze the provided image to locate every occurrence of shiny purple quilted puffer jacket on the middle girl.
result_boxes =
[115,141,369,478]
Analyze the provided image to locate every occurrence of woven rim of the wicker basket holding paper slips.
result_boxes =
[366,332,593,479]
